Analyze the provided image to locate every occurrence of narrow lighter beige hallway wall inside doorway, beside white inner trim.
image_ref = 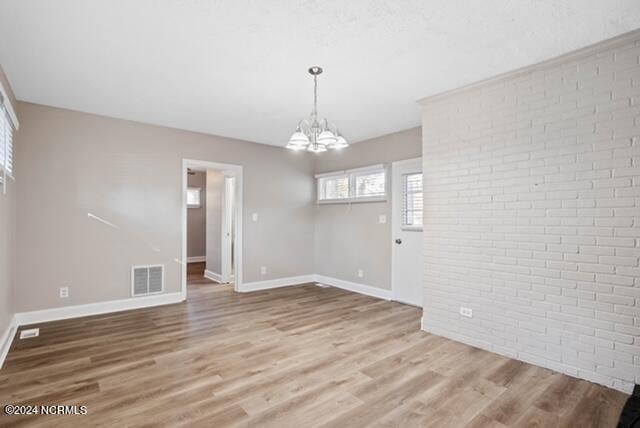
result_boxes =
[207,170,224,274]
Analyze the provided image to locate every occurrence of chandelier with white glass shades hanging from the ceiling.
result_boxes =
[286,66,349,153]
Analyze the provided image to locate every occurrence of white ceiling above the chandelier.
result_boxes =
[0,0,640,145]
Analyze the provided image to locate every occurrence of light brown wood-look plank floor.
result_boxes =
[0,266,626,428]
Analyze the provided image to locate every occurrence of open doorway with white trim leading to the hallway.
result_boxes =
[182,159,242,299]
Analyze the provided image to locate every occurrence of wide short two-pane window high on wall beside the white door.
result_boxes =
[316,165,387,203]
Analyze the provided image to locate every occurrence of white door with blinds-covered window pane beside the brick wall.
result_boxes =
[391,158,423,307]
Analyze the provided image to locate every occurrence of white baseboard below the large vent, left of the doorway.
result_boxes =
[14,292,184,326]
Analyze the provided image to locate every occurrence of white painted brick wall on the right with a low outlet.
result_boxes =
[422,33,640,392]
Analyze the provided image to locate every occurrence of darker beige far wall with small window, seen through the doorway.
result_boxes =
[187,171,207,257]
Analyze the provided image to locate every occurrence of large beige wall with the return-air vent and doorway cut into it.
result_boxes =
[15,102,314,311]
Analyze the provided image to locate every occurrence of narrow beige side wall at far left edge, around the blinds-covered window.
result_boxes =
[0,66,16,338]
